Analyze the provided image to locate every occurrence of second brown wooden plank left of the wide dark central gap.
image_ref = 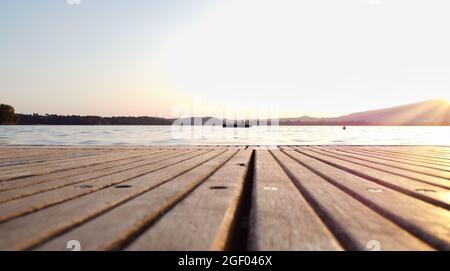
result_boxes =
[38,150,237,250]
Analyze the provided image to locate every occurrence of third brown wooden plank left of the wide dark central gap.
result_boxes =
[0,150,224,250]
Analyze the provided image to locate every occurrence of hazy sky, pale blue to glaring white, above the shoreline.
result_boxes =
[0,0,450,116]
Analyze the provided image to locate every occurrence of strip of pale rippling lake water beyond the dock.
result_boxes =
[0,125,450,145]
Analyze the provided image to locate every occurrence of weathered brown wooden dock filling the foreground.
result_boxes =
[0,145,450,250]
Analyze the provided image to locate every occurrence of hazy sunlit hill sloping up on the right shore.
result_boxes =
[280,99,450,125]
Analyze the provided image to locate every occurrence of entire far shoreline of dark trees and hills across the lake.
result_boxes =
[0,102,450,127]
